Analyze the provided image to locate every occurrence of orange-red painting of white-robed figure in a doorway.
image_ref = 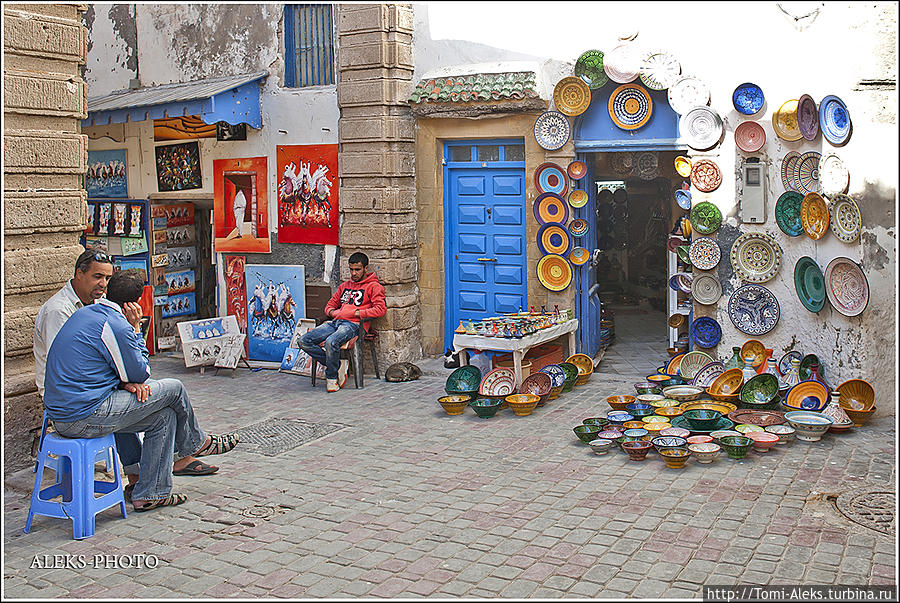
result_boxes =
[213,157,271,253]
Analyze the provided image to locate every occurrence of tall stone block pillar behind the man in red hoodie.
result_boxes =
[337,4,422,366]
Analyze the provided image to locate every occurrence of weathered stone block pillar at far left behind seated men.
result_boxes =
[3,4,87,472]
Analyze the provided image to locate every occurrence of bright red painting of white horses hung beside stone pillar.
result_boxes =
[275,144,339,245]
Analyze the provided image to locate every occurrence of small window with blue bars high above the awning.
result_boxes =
[284,4,335,88]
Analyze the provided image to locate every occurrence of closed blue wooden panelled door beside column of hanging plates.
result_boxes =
[444,143,528,347]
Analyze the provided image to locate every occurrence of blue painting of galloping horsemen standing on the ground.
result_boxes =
[244,264,306,364]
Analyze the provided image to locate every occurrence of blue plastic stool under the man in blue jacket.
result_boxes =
[25,433,127,539]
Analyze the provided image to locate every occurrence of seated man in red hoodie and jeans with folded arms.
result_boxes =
[300,252,387,392]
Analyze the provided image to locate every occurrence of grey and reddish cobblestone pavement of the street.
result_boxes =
[4,315,896,599]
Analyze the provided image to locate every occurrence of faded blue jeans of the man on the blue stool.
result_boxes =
[53,379,206,500]
